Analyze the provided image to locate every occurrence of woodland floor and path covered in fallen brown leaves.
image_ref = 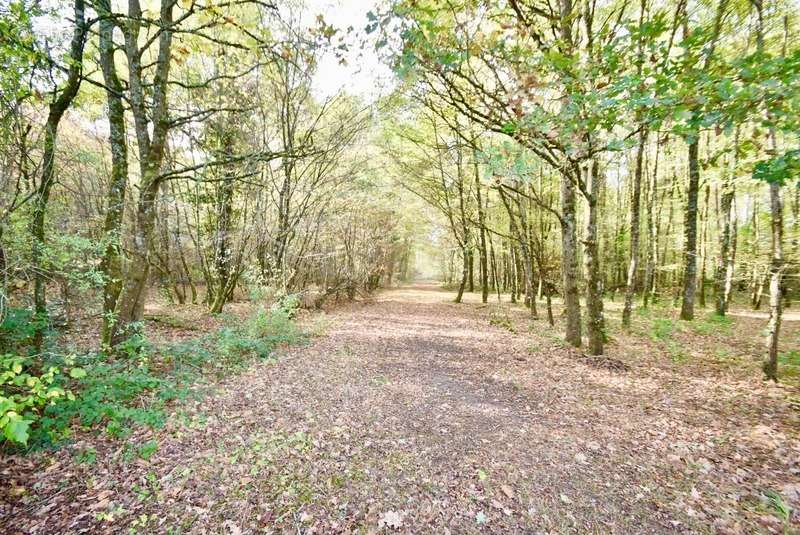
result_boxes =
[0,286,800,535]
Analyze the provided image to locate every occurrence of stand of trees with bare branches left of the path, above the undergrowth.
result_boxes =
[0,0,411,349]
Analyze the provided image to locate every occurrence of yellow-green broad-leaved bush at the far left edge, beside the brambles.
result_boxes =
[0,354,86,446]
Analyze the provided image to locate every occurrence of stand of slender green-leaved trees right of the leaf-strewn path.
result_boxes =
[380,0,798,368]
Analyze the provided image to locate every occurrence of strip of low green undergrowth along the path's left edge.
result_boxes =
[0,300,308,449]
